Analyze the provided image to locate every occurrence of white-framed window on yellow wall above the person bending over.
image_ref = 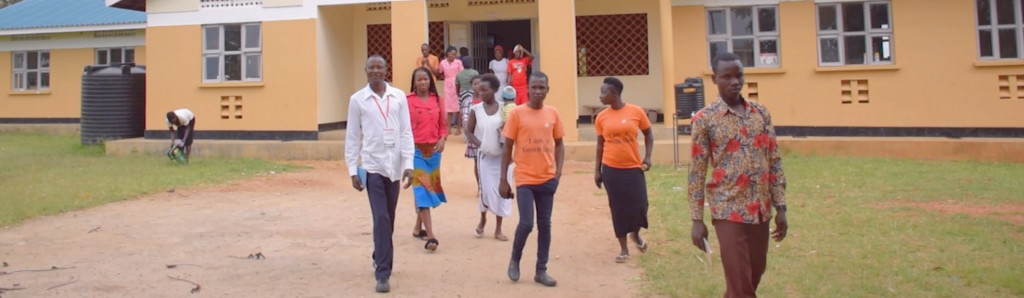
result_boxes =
[203,24,263,83]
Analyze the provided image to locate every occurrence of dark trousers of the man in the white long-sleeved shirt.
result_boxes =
[365,173,400,280]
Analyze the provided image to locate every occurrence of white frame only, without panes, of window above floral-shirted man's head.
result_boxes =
[705,5,782,69]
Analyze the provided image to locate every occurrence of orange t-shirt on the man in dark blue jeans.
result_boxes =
[502,104,565,186]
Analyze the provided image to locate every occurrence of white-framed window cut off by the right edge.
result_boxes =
[975,0,1024,59]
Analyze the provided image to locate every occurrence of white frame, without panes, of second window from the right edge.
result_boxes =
[814,0,897,67]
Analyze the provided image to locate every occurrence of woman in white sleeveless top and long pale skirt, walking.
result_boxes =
[466,74,512,241]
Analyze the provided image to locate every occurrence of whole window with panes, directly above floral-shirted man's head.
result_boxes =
[708,6,779,68]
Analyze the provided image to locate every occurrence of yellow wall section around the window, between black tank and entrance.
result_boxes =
[146,19,317,131]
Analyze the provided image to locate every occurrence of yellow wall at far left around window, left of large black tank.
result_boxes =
[0,48,94,118]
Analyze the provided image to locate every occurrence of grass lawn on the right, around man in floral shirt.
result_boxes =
[640,156,1024,297]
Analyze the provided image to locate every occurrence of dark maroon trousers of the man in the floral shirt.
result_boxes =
[712,219,769,298]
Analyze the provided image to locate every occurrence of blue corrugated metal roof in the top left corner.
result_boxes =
[0,0,145,30]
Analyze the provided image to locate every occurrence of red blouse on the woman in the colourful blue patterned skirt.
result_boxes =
[406,93,447,143]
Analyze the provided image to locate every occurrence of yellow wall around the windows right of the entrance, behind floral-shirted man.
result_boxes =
[673,0,1024,127]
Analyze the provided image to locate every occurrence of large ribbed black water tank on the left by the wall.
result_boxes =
[81,63,145,145]
